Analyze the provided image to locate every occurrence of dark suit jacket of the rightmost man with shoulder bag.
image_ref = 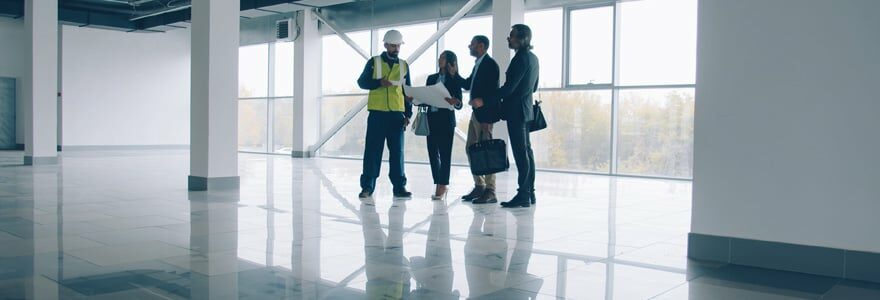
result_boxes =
[495,50,538,123]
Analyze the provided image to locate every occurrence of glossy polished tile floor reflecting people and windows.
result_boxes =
[0,150,880,299]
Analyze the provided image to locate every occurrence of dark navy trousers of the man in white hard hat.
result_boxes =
[361,111,406,192]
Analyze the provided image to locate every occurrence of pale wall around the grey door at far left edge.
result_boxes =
[0,18,27,144]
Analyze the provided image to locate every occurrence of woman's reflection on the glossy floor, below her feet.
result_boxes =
[412,201,460,299]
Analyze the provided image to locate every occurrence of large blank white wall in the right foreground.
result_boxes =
[692,0,880,252]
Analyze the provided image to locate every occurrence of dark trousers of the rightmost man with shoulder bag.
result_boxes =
[507,122,535,197]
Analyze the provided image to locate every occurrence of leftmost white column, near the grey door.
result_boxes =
[22,0,58,165]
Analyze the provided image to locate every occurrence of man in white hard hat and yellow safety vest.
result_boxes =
[358,30,412,199]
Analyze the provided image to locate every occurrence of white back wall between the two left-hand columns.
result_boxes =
[62,26,190,146]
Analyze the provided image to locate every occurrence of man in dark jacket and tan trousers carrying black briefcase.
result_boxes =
[462,35,501,204]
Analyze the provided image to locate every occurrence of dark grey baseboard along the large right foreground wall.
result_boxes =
[688,233,880,283]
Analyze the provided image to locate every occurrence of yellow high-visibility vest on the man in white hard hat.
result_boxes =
[367,56,409,112]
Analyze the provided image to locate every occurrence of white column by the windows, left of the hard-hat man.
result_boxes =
[292,10,321,157]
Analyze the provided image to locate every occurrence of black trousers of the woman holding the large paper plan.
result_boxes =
[428,109,455,185]
